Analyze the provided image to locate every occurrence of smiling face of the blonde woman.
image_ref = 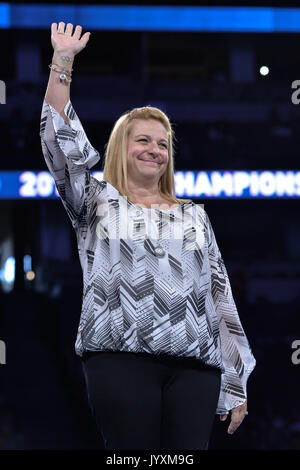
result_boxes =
[127,119,169,184]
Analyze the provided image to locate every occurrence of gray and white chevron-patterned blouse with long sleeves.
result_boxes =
[40,100,256,414]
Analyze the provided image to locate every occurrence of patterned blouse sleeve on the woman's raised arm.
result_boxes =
[40,99,100,228]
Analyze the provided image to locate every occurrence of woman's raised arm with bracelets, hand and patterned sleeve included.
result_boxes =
[40,22,100,229]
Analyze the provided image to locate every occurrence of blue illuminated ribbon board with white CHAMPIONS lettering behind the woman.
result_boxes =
[0,170,300,200]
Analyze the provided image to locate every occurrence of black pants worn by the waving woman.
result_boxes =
[82,351,221,450]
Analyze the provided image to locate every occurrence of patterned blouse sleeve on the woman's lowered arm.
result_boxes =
[205,213,256,414]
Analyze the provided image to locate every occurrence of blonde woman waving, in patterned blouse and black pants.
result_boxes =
[40,22,255,450]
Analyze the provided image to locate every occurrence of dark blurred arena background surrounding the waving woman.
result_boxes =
[0,0,300,450]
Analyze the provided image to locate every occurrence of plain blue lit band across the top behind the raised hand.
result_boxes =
[0,3,300,33]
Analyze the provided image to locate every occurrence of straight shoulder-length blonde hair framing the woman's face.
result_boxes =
[103,106,190,203]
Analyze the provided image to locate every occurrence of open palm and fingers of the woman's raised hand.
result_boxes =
[51,21,90,55]
